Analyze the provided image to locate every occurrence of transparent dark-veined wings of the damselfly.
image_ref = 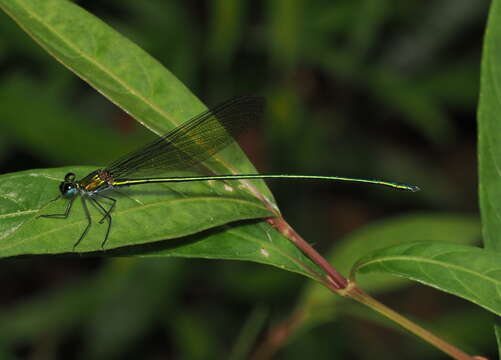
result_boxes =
[106,96,265,180]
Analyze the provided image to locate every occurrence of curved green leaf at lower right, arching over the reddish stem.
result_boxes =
[351,242,501,315]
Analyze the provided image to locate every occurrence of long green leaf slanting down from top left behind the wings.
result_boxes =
[0,0,271,191]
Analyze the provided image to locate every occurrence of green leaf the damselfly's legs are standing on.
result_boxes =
[0,167,272,256]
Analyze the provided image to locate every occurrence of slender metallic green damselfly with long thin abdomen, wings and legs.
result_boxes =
[40,96,418,249]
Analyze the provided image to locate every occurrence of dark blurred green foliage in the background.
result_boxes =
[0,0,488,359]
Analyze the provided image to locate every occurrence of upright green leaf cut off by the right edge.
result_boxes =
[478,0,501,251]
